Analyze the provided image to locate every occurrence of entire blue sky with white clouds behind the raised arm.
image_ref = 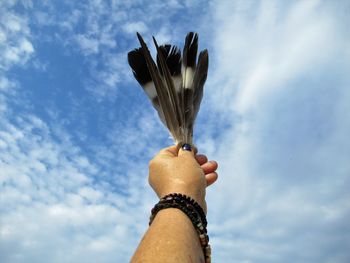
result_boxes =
[0,0,350,263]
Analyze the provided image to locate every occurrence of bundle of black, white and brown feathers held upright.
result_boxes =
[128,32,209,145]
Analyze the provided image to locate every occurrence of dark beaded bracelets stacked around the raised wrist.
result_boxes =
[149,193,211,263]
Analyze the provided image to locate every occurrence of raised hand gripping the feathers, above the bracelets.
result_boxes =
[149,146,218,211]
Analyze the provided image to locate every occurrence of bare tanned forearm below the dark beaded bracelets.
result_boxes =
[131,208,204,263]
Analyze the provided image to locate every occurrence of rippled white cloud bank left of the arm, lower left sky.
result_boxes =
[0,108,159,262]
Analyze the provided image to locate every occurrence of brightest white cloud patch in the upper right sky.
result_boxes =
[209,1,337,113]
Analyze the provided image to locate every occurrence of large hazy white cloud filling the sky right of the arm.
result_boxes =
[207,1,350,262]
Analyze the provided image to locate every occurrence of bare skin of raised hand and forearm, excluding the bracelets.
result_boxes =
[131,146,218,263]
